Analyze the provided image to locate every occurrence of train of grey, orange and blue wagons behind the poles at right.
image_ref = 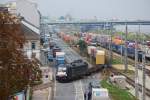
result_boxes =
[84,33,150,62]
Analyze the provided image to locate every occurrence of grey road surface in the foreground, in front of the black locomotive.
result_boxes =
[54,73,100,100]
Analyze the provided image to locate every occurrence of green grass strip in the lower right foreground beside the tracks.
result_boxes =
[101,80,136,100]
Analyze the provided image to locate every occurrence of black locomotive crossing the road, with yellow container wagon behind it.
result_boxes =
[56,50,106,81]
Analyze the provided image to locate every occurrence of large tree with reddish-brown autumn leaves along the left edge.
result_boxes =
[0,12,40,100]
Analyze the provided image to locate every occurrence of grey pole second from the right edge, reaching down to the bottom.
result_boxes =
[135,25,139,99]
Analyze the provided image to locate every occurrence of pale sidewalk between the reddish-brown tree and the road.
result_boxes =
[32,66,52,100]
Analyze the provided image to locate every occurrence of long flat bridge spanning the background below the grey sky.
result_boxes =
[44,21,150,26]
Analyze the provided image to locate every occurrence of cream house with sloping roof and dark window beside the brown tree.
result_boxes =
[21,20,40,61]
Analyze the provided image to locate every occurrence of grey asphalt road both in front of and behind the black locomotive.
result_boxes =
[52,35,100,100]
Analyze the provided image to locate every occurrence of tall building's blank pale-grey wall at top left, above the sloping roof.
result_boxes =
[6,0,40,28]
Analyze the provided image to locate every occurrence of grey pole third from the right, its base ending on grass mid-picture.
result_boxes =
[125,24,128,71]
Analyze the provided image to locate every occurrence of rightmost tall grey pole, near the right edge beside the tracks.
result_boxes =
[139,25,146,100]
